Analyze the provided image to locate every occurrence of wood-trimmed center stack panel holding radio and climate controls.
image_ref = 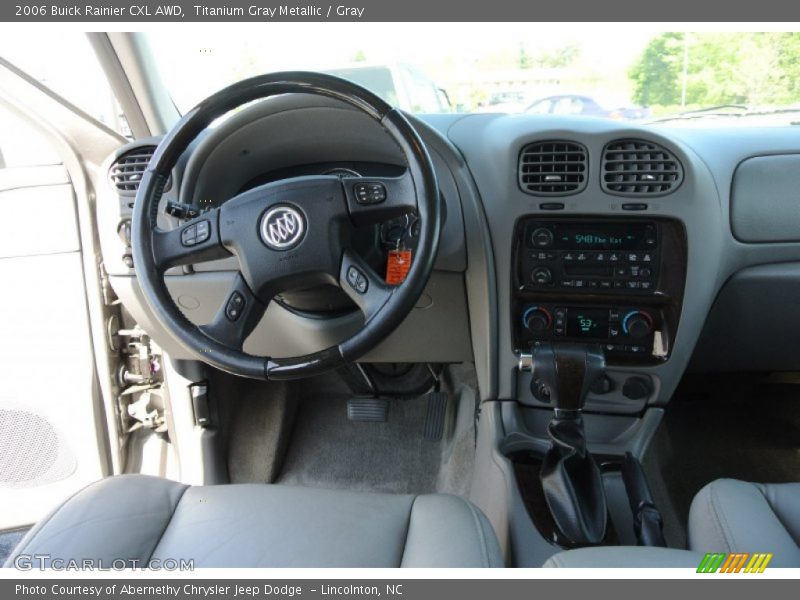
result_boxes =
[511,215,686,365]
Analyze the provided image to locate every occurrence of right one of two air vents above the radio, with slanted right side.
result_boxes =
[601,140,683,196]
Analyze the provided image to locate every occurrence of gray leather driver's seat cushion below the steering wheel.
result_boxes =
[6,475,503,567]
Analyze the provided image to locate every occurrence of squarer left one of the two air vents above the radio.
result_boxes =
[519,141,588,196]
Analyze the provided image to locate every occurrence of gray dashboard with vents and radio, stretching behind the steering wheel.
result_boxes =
[97,97,800,413]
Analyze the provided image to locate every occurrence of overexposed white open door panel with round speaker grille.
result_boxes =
[0,106,103,529]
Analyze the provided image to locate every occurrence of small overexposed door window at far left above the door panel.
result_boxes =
[0,106,61,172]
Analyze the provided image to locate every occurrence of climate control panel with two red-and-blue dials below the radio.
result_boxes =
[518,303,662,356]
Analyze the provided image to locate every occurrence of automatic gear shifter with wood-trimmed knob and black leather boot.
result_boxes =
[531,343,608,546]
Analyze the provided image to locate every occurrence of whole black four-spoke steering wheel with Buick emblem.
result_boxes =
[131,72,441,380]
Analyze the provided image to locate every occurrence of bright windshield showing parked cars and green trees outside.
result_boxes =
[148,23,800,124]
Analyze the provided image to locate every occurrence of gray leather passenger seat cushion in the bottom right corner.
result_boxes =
[689,479,800,567]
